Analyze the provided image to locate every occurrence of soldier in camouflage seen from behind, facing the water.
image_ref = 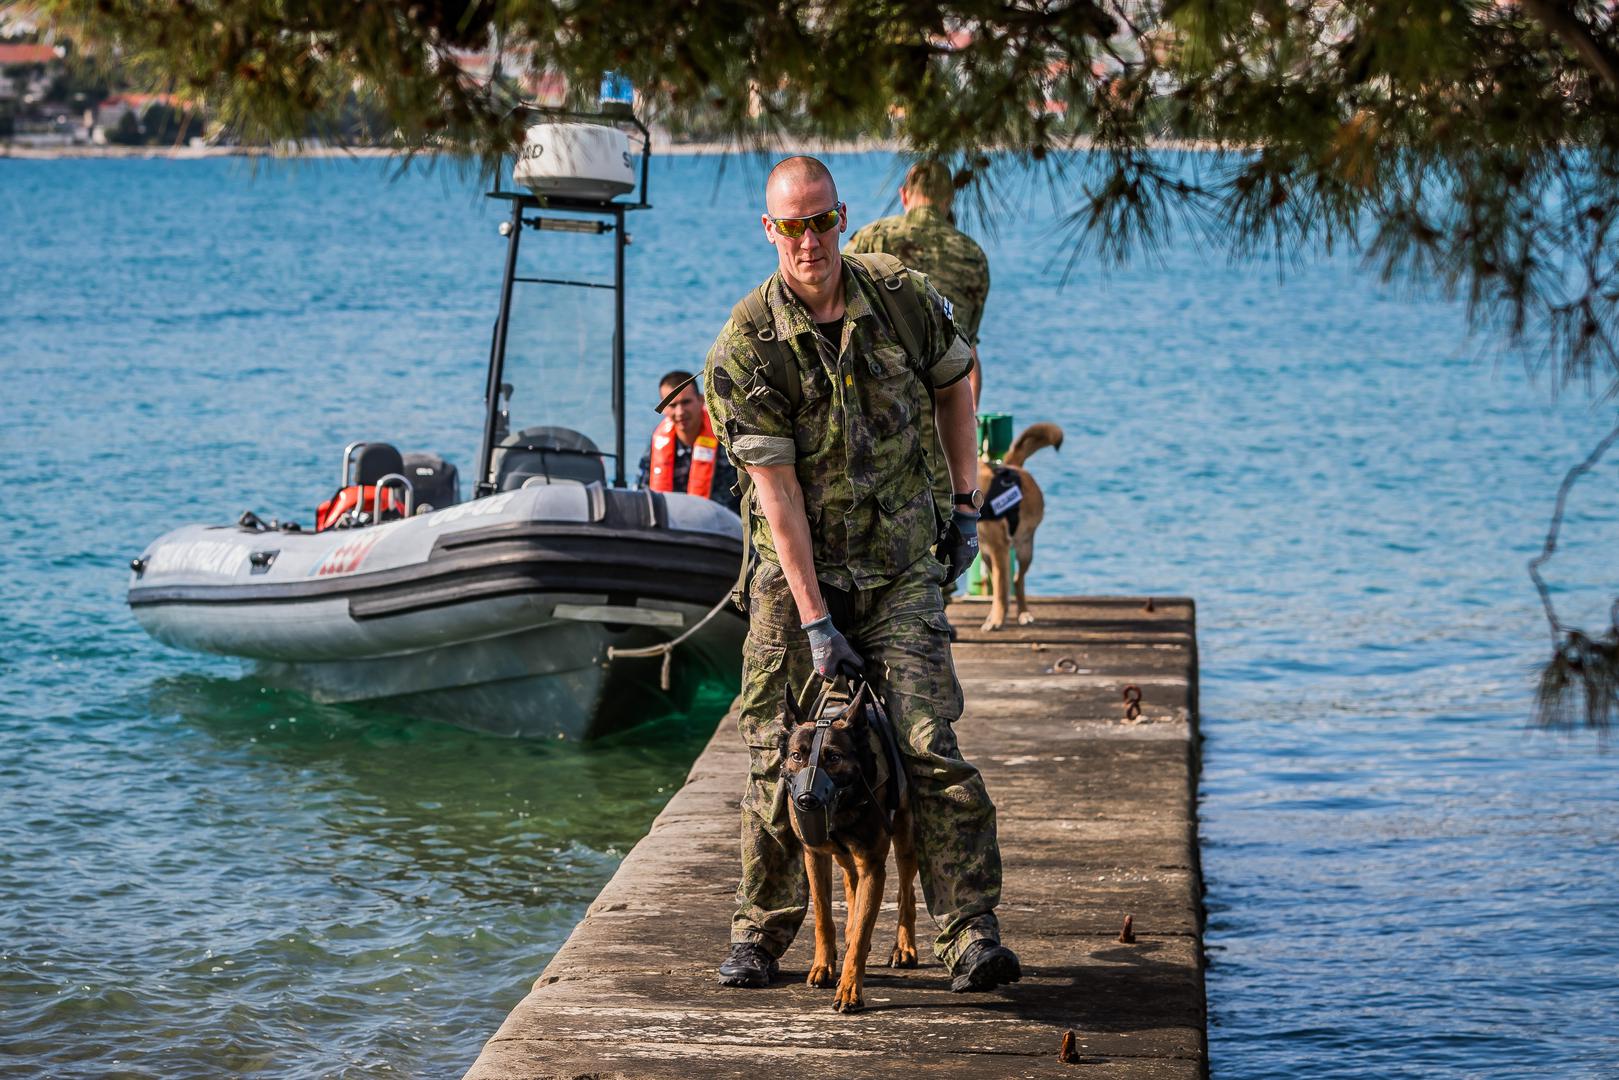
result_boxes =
[843,162,989,405]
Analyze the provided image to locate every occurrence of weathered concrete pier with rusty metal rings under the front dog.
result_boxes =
[466,597,1206,1080]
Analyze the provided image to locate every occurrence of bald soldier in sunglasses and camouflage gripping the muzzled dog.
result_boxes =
[704,157,1020,991]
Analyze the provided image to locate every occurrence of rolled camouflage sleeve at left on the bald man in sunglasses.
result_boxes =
[703,321,798,466]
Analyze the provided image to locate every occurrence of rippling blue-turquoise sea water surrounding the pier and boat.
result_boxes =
[0,155,1619,1077]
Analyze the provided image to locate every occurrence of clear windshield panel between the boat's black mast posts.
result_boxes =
[504,228,614,473]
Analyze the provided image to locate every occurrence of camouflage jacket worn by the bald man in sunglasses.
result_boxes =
[703,262,973,589]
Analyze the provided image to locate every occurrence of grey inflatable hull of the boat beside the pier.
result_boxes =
[130,484,745,738]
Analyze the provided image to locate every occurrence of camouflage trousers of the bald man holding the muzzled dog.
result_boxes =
[730,555,1001,965]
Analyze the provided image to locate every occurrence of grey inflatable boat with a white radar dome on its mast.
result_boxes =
[128,110,745,738]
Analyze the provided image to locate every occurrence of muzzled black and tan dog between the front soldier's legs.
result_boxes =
[782,680,916,1012]
